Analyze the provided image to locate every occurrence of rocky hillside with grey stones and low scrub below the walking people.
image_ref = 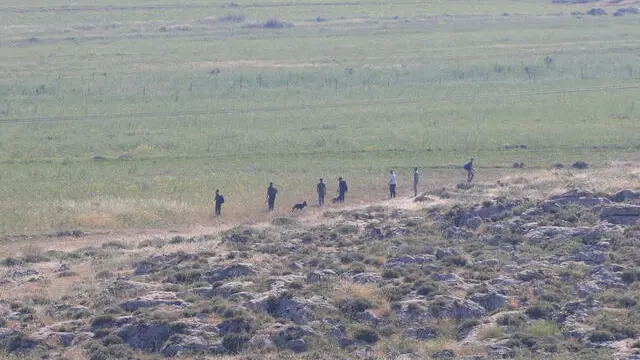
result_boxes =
[0,190,640,360]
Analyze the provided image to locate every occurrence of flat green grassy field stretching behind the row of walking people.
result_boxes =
[0,0,640,233]
